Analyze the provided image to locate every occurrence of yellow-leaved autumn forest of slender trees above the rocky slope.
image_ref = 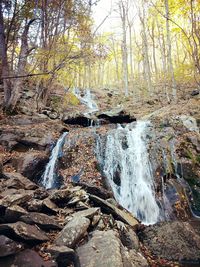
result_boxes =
[0,0,200,112]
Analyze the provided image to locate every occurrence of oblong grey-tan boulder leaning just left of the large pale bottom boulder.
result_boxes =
[55,216,90,248]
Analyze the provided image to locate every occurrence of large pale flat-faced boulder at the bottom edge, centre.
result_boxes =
[77,230,124,267]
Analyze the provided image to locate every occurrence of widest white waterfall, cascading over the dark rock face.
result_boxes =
[97,121,160,224]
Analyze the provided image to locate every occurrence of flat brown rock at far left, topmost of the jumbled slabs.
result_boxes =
[4,172,38,190]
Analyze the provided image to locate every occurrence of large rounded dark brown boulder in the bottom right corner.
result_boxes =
[141,221,200,262]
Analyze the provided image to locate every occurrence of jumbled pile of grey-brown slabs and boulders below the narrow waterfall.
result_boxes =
[0,170,148,267]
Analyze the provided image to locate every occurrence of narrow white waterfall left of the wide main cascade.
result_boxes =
[41,132,68,189]
